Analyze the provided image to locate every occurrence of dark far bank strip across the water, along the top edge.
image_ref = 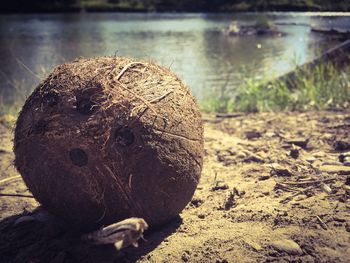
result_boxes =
[0,0,350,13]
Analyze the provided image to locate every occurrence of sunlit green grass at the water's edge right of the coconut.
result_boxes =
[201,64,350,113]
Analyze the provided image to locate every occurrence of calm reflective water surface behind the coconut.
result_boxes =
[0,13,350,100]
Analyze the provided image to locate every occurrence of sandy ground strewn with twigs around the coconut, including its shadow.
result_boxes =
[0,111,350,263]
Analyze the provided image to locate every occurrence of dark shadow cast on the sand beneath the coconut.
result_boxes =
[0,208,182,263]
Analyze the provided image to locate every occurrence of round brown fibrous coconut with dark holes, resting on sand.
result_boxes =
[14,57,203,228]
